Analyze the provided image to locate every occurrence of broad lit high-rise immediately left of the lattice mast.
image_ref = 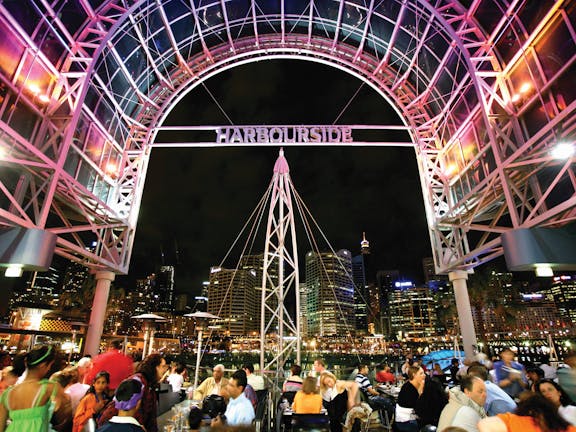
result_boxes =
[208,267,258,336]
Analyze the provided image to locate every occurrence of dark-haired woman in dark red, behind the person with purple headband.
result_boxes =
[98,353,168,432]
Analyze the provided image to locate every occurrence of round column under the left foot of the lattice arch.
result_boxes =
[84,271,116,356]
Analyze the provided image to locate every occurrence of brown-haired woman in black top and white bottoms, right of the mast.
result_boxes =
[395,366,426,432]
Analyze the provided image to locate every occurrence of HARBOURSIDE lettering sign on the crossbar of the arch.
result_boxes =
[216,126,353,144]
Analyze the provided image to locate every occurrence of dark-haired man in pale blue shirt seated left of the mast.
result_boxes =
[211,370,255,427]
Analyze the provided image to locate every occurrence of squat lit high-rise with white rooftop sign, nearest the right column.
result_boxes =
[388,281,436,339]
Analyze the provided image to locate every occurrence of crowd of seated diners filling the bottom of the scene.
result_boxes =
[0,341,576,432]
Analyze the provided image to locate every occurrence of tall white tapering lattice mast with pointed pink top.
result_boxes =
[260,149,301,382]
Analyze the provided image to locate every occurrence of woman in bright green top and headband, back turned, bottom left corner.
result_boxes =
[0,345,72,432]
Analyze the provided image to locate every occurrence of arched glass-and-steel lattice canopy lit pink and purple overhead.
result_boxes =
[0,0,576,273]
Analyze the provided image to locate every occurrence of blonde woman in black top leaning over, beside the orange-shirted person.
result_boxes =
[320,372,360,432]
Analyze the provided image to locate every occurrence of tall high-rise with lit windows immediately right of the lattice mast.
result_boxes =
[306,249,355,336]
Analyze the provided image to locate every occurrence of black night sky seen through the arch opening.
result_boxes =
[117,60,431,293]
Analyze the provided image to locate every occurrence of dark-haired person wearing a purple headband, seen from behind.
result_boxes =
[97,379,147,432]
